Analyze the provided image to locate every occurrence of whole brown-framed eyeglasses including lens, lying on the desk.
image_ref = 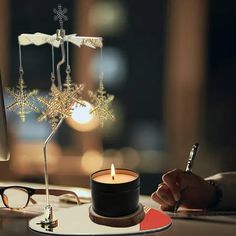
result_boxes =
[0,186,80,210]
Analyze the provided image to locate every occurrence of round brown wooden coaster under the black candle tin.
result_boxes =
[89,203,145,227]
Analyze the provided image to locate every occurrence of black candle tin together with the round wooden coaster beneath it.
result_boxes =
[89,169,145,227]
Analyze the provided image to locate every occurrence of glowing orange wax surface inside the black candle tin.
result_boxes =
[94,174,137,184]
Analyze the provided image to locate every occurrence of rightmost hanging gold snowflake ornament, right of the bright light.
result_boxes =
[88,75,115,127]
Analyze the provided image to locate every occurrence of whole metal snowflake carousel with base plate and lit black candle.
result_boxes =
[7,5,171,235]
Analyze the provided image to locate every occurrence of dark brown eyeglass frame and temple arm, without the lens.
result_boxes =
[0,185,81,210]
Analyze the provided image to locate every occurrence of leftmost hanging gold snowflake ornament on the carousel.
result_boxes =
[7,75,39,122]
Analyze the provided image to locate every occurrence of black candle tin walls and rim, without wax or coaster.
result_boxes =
[90,168,140,217]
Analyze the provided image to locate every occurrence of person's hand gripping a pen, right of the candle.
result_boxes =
[151,169,215,211]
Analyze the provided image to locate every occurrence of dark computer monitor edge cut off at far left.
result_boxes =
[0,73,10,161]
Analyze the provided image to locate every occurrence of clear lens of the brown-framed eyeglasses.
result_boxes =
[4,187,28,209]
